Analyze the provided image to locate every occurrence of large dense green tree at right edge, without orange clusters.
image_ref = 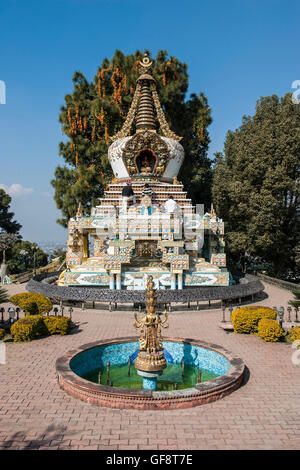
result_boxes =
[212,94,300,276]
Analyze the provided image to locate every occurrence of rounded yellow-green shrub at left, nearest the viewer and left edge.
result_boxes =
[10,315,48,342]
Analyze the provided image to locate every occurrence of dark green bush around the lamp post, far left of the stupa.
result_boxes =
[7,240,48,274]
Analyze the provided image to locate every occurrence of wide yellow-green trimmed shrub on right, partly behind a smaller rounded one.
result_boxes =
[231,306,277,334]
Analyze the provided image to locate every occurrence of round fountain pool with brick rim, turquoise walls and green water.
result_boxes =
[56,337,244,409]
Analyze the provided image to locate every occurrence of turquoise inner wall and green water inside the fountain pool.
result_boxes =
[70,341,230,390]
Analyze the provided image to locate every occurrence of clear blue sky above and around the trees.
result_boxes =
[0,0,300,242]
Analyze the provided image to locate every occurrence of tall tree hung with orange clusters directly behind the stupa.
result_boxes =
[51,51,212,227]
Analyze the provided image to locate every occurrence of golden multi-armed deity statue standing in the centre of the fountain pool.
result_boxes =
[134,276,169,372]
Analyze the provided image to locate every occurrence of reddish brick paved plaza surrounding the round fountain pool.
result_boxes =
[0,284,300,450]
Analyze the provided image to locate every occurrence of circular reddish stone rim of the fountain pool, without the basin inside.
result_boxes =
[56,336,245,410]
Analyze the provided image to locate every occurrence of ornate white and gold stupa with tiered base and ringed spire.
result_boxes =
[58,55,230,290]
